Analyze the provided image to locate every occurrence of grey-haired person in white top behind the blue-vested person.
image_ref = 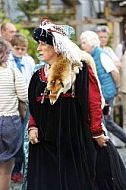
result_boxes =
[96,25,121,70]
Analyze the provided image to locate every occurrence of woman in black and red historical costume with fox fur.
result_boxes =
[27,19,125,190]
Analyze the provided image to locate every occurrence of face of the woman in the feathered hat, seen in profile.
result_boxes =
[37,41,57,64]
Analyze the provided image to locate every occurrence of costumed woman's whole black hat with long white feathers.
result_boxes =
[32,17,82,66]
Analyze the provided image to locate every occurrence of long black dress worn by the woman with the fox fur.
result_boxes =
[27,63,124,190]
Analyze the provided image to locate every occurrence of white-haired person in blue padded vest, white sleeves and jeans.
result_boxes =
[80,31,126,143]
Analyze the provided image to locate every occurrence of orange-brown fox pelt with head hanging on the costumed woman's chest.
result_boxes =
[47,55,81,105]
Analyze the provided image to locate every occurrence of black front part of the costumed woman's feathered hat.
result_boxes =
[32,27,53,46]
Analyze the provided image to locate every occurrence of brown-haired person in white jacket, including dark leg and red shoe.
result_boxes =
[8,33,35,182]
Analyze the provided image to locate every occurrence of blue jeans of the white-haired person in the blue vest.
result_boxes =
[104,98,126,143]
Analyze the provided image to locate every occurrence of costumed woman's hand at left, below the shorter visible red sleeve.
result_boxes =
[28,128,39,144]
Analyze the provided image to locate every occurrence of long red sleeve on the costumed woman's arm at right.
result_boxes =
[88,66,103,137]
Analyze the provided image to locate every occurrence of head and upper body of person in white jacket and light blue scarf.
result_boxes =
[8,33,35,86]
